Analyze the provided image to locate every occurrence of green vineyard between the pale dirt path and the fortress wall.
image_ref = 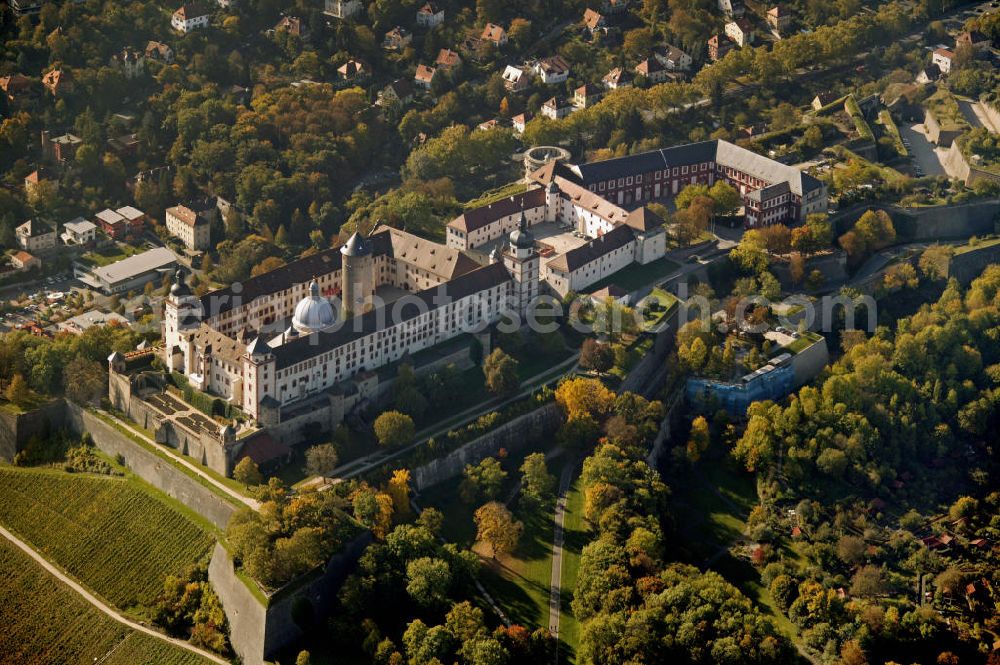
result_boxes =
[0,467,212,612]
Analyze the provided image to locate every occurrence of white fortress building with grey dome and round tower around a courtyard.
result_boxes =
[162,222,539,426]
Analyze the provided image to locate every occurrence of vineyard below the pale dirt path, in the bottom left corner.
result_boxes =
[0,540,208,665]
